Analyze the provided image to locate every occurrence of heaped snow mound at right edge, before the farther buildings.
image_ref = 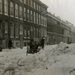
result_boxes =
[53,42,75,55]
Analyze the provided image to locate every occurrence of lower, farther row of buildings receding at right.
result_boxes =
[47,12,75,44]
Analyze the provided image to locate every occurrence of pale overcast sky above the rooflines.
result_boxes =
[41,0,75,26]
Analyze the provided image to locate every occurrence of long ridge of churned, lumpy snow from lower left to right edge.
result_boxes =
[0,42,75,75]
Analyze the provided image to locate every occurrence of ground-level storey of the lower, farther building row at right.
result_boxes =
[47,32,72,45]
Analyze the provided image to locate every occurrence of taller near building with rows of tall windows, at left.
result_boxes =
[0,0,48,47]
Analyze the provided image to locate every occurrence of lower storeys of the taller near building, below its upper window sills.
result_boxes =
[0,17,47,48]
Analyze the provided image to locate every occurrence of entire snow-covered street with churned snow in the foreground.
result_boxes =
[0,42,75,75]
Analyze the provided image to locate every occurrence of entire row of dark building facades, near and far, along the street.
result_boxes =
[0,0,75,48]
